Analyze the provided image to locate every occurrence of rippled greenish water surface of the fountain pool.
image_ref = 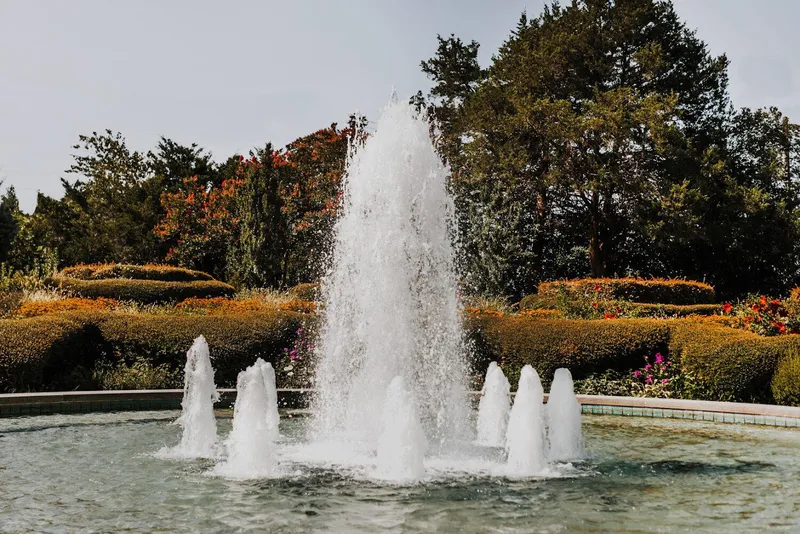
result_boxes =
[0,412,800,533]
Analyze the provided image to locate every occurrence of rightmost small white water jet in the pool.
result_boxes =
[546,368,584,462]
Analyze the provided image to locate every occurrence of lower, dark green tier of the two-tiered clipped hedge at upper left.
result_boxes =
[45,276,236,304]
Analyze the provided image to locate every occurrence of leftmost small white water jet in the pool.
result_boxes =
[161,336,219,458]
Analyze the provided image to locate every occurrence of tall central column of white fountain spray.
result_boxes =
[313,102,468,451]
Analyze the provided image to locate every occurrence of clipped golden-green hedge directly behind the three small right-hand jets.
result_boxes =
[467,315,669,390]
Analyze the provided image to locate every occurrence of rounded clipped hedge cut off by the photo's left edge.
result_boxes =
[0,313,102,393]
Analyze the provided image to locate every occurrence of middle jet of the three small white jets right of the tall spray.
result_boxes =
[506,365,547,477]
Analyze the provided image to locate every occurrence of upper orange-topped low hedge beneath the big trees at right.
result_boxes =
[539,278,716,304]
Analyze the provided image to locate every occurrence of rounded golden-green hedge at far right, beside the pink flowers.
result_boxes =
[669,320,800,402]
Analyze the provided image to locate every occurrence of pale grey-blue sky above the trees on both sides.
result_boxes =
[0,0,800,212]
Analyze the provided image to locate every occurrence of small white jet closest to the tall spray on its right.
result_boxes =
[476,362,511,447]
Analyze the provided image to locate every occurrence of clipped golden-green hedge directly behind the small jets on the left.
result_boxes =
[99,310,313,387]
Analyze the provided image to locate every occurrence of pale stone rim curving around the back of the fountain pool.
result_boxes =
[0,389,800,428]
